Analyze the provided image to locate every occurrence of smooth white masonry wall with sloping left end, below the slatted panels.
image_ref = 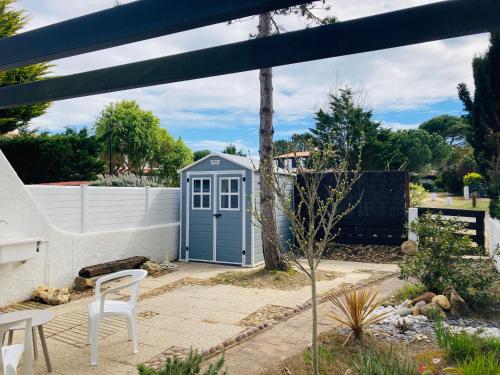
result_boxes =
[0,151,179,306]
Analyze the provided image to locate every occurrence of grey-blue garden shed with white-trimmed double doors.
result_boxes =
[179,153,292,267]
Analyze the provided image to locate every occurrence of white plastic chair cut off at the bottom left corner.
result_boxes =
[0,318,33,375]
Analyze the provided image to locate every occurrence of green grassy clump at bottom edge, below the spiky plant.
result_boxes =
[351,348,418,375]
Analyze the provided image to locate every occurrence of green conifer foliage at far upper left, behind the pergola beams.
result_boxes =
[0,0,50,135]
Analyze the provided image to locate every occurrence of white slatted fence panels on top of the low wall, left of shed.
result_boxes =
[26,185,180,233]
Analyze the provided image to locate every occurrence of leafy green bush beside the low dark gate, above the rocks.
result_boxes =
[399,213,496,308]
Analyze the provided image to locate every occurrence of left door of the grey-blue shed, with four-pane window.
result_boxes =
[188,174,214,261]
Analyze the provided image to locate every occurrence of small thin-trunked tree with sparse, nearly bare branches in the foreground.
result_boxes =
[253,140,363,375]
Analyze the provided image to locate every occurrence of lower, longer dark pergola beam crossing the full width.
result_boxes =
[0,0,500,108]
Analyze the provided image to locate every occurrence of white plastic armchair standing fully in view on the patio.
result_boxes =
[87,270,148,366]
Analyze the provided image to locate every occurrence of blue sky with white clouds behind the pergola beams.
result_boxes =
[16,0,488,155]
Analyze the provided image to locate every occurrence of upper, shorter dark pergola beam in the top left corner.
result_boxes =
[0,0,312,70]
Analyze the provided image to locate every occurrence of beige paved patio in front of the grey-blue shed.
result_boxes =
[7,261,398,375]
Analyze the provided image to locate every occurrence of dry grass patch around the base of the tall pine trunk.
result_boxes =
[210,268,343,290]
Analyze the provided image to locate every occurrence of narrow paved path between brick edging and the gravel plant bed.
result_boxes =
[209,277,404,375]
